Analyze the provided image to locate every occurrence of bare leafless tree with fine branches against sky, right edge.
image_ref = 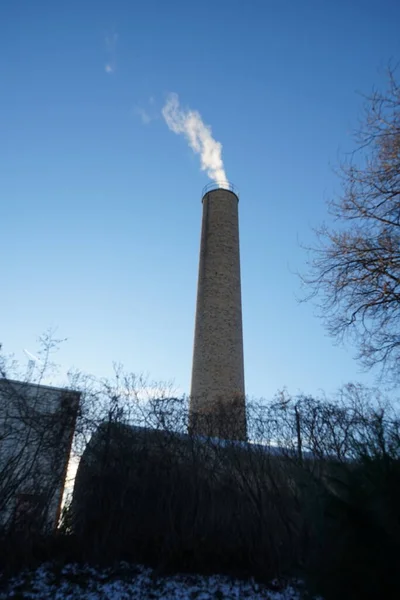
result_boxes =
[302,69,400,379]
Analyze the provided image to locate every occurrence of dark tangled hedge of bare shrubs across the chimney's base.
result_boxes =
[0,336,400,600]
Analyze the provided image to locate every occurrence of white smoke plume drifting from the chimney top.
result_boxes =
[162,94,227,182]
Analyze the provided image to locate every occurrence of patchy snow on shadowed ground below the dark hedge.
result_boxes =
[0,563,321,600]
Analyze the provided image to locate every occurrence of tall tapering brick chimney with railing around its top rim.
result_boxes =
[189,183,247,440]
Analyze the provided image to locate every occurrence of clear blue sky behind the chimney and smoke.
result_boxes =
[0,0,400,398]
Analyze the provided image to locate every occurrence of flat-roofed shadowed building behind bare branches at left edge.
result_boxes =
[0,379,80,532]
